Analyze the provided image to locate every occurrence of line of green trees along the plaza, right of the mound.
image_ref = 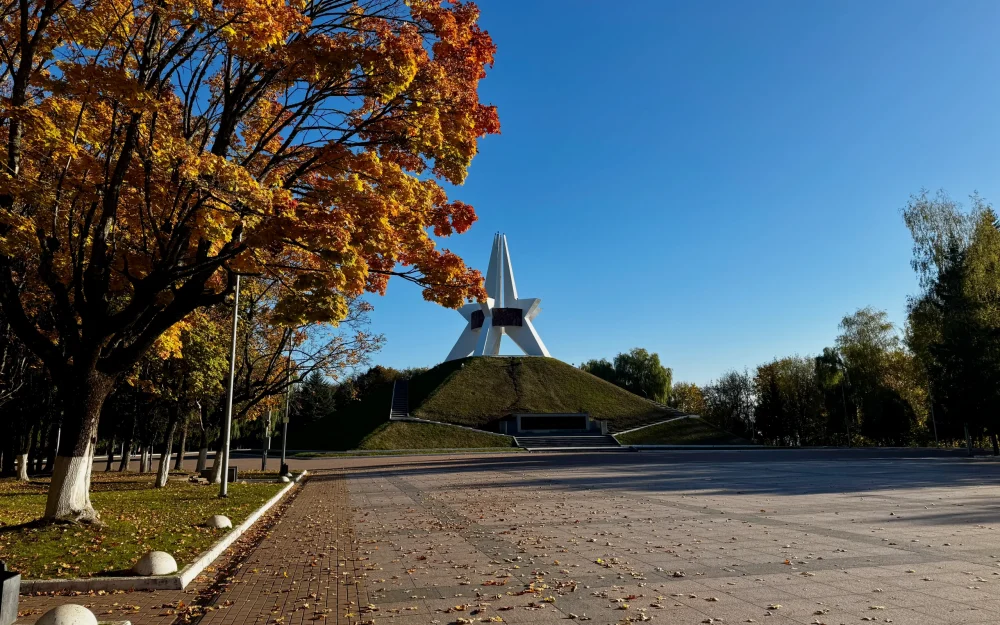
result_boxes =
[581,191,1000,453]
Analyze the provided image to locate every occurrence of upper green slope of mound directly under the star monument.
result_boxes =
[410,357,681,432]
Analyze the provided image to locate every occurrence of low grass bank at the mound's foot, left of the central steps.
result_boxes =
[358,421,514,449]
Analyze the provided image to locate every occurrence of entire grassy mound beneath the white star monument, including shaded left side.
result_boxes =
[288,357,683,451]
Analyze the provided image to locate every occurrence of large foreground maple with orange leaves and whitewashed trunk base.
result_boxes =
[0,0,499,520]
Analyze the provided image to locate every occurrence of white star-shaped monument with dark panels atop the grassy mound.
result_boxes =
[447,233,549,360]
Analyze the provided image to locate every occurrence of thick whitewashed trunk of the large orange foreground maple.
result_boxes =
[45,370,115,522]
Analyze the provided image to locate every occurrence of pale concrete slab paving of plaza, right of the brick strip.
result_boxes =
[340,454,1000,625]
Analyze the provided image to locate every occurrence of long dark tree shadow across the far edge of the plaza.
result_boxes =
[314,450,1000,500]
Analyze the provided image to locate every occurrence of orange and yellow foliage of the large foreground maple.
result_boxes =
[0,0,499,370]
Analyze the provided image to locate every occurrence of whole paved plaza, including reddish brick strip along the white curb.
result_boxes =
[15,451,1000,625]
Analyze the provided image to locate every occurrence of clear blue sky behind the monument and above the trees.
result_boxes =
[364,0,1000,383]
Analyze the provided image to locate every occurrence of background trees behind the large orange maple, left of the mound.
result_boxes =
[0,279,383,487]
